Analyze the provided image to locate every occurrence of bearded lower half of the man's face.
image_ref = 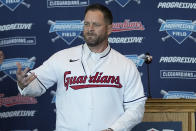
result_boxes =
[84,32,107,47]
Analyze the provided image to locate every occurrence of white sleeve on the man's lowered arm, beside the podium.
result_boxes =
[110,59,146,131]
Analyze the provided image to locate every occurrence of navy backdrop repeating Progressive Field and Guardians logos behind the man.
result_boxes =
[0,0,196,131]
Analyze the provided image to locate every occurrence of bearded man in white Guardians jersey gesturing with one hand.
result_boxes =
[16,4,146,131]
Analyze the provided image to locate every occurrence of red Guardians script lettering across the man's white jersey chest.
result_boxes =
[64,71,122,90]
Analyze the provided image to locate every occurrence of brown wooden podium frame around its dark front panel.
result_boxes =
[143,99,196,131]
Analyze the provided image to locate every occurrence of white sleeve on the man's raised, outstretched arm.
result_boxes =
[18,52,57,97]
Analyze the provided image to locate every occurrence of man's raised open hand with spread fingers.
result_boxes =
[16,62,36,89]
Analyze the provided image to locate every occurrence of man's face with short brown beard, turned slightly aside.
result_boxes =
[83,10,111,47]
